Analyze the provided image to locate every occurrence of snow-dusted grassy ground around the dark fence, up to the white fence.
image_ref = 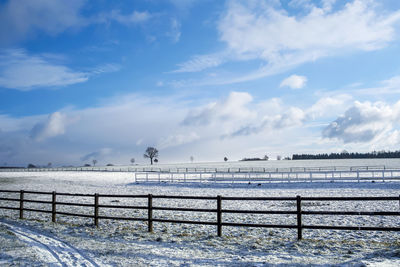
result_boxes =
[0,172,400,266]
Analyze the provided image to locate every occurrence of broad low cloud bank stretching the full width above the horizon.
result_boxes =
[0,89,400,165]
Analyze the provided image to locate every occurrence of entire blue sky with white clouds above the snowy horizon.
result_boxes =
[0,0,400,166]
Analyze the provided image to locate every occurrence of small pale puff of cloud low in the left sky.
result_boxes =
[31,112,66,141]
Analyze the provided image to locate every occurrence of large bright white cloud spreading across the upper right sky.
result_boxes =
[173,0,400,84]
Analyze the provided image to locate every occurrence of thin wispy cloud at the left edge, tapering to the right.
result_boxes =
[0,49,88,91]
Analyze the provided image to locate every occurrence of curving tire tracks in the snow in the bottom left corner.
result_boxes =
[0,221,98,267]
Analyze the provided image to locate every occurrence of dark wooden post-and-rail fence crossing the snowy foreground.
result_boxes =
[0,190,400,240]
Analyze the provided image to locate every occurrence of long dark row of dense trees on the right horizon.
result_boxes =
[292,150,400,160]
